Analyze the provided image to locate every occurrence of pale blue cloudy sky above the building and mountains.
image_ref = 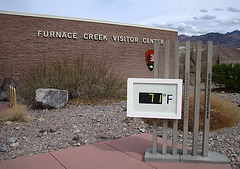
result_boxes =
[0,0,240,36]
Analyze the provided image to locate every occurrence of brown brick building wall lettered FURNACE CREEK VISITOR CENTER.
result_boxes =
[0,11,178,82]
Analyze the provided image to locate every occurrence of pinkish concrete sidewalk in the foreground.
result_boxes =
[0,133,231,169]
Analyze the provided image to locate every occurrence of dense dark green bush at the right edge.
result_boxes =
[212,63,240,91]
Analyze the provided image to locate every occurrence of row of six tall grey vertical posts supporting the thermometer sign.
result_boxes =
[148,41,213,161]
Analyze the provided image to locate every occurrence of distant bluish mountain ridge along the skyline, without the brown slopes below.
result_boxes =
[178,30,240,48]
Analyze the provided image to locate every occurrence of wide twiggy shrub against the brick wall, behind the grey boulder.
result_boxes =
[20,58,125,101]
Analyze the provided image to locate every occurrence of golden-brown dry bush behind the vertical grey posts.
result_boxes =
[143,93,240,131]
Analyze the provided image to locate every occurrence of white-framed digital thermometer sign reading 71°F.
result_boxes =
[127,78,182,119]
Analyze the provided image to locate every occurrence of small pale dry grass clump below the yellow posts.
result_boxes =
[1,105,34,122]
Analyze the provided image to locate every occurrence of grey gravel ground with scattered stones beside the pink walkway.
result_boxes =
[0,92,240,168]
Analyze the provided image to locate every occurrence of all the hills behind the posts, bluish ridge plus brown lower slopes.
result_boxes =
[178,31,240,83]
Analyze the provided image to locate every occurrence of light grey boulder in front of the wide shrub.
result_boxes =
[35,89,68,109]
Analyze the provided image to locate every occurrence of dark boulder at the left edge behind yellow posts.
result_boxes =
[0,77,18,101]
